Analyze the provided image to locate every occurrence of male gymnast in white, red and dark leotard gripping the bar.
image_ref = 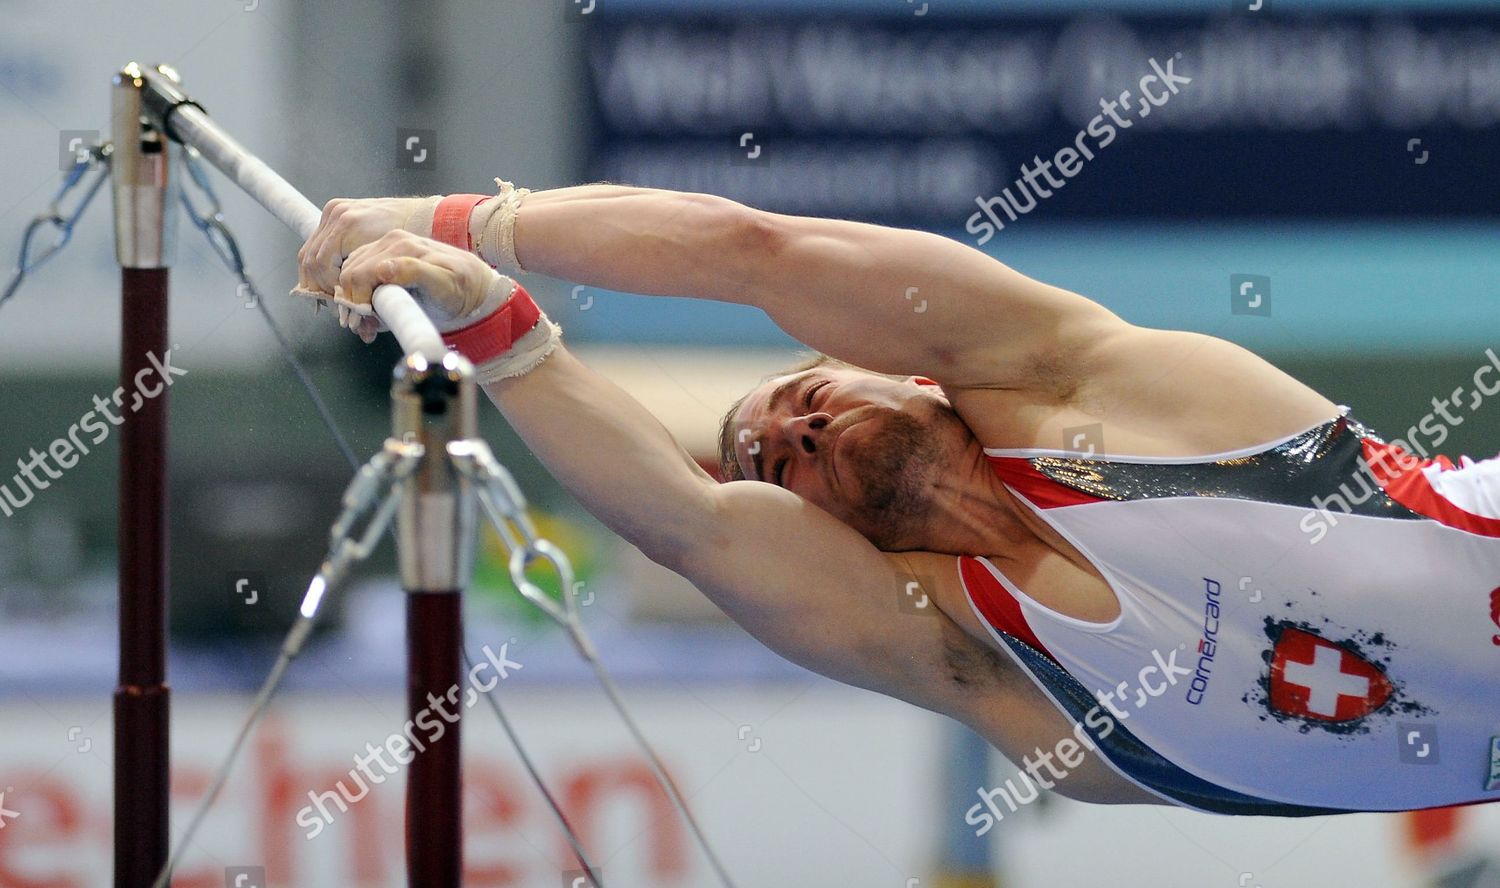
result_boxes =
[299,183,1500,824]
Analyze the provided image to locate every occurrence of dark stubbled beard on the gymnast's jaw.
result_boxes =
[840,413,942,549]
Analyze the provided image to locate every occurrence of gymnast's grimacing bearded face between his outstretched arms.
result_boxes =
[734,366,969,549]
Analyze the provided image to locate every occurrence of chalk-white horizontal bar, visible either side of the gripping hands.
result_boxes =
[171,105,447,362]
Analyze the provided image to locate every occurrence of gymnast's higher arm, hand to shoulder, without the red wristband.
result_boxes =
[302,185,1125,389]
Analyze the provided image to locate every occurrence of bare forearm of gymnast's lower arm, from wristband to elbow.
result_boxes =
[485,345,716,563]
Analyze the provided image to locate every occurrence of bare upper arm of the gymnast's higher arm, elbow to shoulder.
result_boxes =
[753,215,1121,386]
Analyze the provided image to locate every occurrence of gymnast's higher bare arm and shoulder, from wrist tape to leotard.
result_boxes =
[516,192,1334,453]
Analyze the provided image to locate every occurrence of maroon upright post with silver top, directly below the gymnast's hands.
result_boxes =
[392,353,477,888]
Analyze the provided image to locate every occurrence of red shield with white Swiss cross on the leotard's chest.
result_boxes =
[1271,626,1392,722]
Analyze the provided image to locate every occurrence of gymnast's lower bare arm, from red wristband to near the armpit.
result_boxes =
[485,340,941,696]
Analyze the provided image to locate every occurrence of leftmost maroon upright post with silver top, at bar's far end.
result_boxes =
[111,63,176,888]
